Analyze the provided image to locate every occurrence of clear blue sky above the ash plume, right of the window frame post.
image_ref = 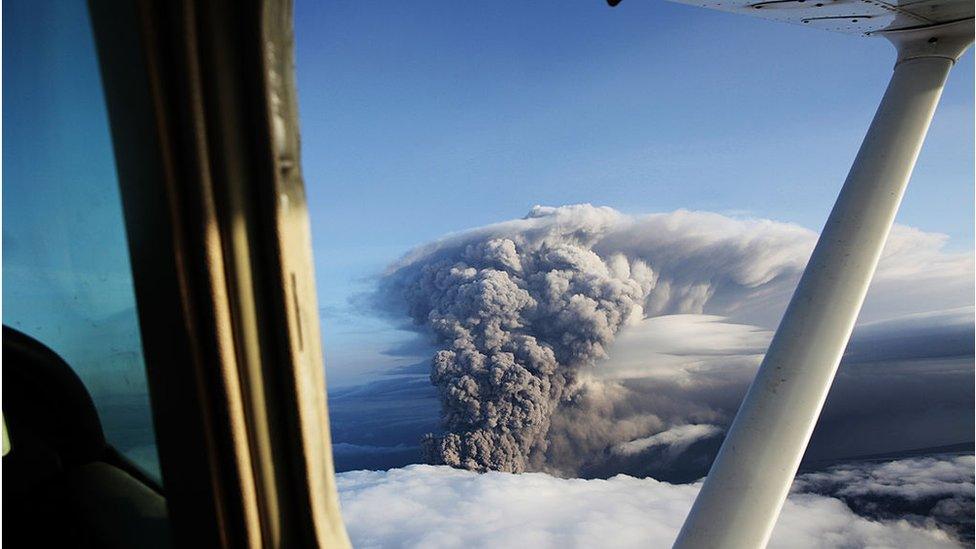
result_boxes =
[295,0,974,385]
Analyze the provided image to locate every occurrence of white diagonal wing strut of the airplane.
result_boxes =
[674,18,973,549]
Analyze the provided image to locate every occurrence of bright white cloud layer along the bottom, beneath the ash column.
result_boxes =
[338,458,973,549]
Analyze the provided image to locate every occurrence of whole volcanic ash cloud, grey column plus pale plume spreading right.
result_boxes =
[375,205,973,474]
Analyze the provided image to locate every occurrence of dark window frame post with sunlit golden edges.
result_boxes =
[89,0,349,547]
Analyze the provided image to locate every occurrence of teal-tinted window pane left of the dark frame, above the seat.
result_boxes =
[3,1,159,479]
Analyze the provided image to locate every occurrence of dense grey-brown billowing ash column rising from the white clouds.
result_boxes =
[407,228,654,471]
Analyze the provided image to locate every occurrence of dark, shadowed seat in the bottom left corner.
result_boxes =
[3,326,172,547]
